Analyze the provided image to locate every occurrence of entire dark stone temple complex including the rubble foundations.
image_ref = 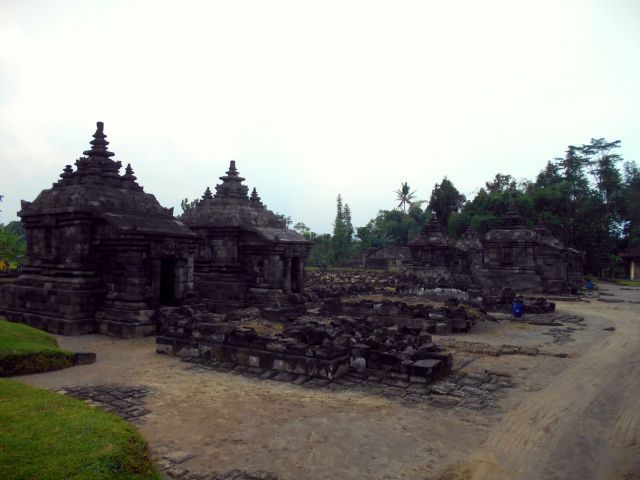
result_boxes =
[0,123,582,387]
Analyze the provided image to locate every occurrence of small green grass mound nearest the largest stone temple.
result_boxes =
[0,319,75,377]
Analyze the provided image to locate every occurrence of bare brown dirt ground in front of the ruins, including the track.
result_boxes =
[19,284,640,480]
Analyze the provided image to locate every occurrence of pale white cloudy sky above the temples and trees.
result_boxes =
[0,0,640,232]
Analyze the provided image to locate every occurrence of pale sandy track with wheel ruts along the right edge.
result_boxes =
[442,286,640,480]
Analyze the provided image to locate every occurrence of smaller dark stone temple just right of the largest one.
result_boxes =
[182,160,312,312]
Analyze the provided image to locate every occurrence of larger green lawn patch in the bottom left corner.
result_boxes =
[0,378,160,480]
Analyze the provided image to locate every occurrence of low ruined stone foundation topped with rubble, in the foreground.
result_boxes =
[156,308,452,384]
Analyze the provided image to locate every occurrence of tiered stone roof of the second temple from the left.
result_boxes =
[181,160,309,243]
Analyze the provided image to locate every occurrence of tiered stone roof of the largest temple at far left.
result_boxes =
[19,122,193,236]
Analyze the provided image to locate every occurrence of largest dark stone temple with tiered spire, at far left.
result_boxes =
[0,122,197,337]
